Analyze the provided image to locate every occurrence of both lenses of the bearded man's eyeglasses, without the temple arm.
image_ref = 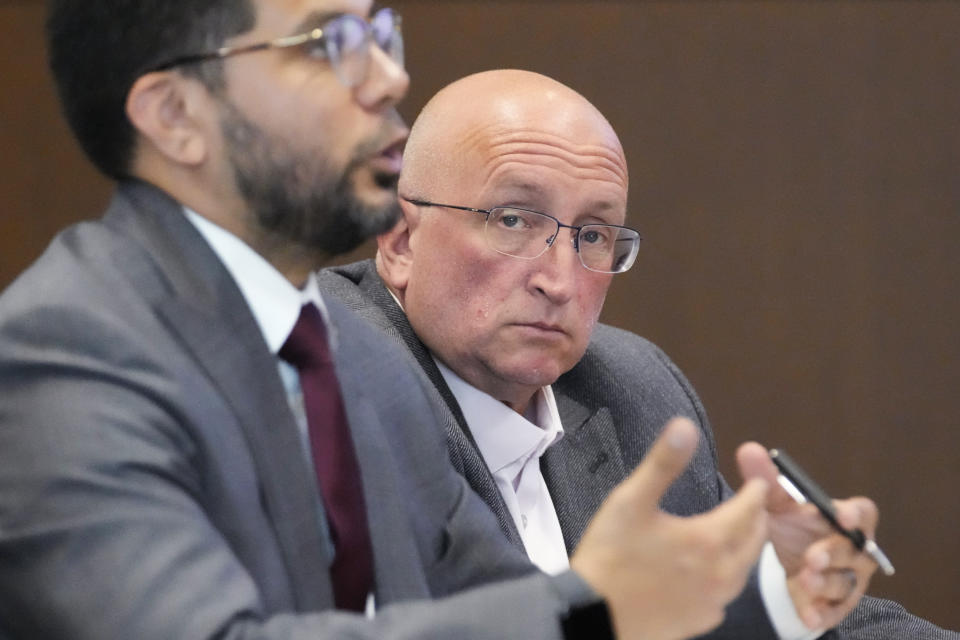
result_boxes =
[324,9,403,87]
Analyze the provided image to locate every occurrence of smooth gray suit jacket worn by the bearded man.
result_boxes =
[0,183,587,640]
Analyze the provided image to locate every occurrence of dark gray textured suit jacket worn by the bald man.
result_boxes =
[320,260,960,640]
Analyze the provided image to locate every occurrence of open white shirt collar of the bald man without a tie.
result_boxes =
[435,359,563,474]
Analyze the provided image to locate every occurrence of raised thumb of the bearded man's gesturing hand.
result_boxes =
[623,418,699,510]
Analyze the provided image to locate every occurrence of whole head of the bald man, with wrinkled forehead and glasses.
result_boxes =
[377,71,637,413]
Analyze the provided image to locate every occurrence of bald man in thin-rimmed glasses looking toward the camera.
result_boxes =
[321,71,956,638]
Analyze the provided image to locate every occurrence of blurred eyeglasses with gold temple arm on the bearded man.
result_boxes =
[149,8,403,87]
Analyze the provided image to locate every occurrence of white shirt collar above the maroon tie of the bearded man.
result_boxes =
[183,207,336,354]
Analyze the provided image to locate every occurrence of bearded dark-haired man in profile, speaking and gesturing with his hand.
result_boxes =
[0,0,784,640]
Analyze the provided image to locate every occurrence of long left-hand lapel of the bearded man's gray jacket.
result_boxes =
[106,184,333,611]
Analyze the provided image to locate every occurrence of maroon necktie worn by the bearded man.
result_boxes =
[280,303,373,611]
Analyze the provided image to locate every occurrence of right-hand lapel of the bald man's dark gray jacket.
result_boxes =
[540,387,627,553]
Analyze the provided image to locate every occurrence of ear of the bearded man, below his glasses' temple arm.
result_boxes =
[126,71,210,166]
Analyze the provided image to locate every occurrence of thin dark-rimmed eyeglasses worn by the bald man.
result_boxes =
[403,198,640,273]
